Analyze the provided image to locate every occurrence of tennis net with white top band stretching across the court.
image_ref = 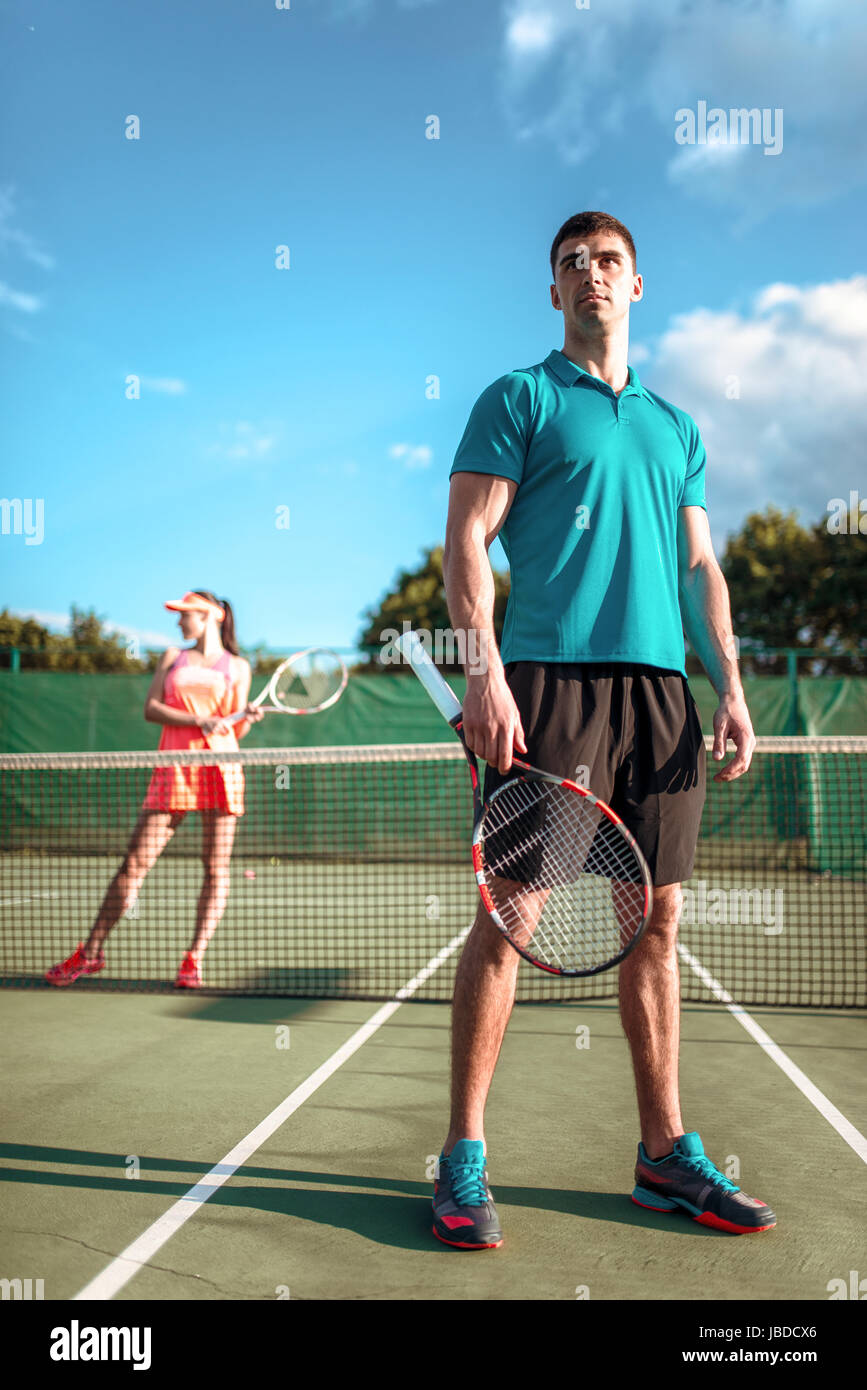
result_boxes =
[0,738,867,1008]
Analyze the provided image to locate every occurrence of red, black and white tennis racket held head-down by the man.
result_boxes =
[395,632,653,976]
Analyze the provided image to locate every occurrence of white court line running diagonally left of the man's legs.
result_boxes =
[72,927,470,1302]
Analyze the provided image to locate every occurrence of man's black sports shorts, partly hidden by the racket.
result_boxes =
[485,662,706,887]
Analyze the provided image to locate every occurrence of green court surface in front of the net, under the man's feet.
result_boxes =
[1,995,867,1301]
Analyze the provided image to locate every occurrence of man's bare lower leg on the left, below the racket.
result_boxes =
[443,905,521,1155]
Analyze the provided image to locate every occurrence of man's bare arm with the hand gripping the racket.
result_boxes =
[443,473,527,773]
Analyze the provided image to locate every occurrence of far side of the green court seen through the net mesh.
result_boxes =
[0,855,867,1008]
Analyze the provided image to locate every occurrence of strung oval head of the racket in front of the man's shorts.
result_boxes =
[479,780,645,972]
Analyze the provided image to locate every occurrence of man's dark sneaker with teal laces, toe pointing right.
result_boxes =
[632,1131,777,1236]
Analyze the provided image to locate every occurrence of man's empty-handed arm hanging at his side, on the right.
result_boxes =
[678,507,756,781]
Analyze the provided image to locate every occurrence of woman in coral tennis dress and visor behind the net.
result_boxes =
[46,589,263,990]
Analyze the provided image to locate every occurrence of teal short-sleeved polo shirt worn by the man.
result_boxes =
[452,350,706,674]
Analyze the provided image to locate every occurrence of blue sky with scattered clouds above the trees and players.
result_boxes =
[0,0,867,649]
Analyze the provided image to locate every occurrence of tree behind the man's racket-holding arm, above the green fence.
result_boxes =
[358,545,509,671]
